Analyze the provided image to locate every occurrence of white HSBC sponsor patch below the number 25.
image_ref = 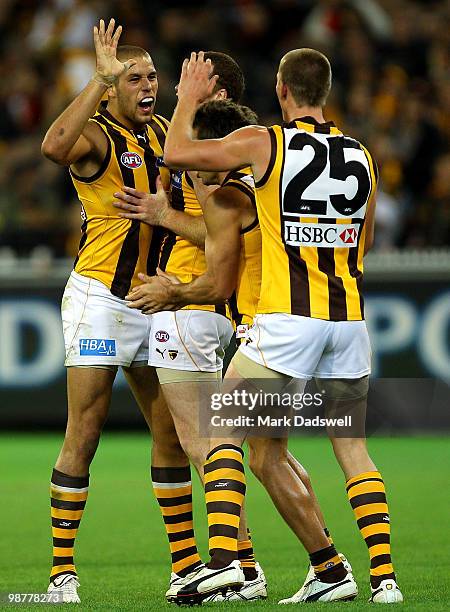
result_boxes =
[284,221,359,248]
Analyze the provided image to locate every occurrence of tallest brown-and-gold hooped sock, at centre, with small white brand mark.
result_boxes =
[205,444,245,569]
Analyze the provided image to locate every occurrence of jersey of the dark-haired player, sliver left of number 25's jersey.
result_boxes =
[222,168,261,338]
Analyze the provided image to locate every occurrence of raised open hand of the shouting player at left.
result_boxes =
[94,19,136,86]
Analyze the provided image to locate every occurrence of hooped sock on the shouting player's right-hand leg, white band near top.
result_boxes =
[152,465,202,576]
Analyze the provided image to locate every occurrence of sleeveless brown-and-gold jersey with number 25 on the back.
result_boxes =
[256,117,377,321]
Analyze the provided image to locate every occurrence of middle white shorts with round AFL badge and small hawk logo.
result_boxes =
[148,310,233,372]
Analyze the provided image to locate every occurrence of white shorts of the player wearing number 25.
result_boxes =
[239,313,371,379]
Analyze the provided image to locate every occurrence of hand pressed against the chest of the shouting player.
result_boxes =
[113,176,172,225]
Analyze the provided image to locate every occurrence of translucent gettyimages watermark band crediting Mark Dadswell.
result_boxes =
[199,377,450,438]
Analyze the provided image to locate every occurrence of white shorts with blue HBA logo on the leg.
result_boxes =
[61,272,151,366]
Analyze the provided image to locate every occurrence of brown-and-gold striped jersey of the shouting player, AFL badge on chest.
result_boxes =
[70,108,169,299]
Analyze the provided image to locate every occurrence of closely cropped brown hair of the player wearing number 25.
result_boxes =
[280,49,331,106]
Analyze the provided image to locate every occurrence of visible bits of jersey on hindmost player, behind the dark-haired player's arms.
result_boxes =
[159,171,229,316]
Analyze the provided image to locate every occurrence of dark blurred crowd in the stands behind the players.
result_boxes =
[0,0,450,258]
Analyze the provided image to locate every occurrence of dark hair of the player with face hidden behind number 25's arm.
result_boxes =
[194,100,258,140]
